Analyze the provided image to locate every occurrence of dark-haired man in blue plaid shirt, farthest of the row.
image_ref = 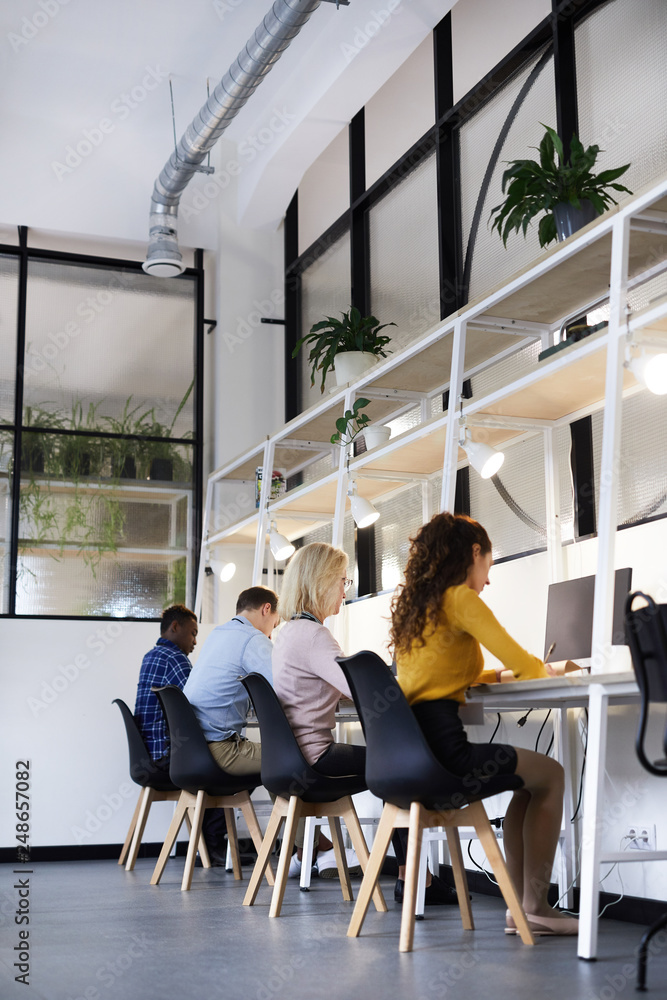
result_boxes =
[134,604,199,771]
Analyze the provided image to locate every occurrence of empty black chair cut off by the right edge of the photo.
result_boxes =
[625,590,667,991]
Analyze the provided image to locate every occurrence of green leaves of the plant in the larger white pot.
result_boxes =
[292,306,396,392]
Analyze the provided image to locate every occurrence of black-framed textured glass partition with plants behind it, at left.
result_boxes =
[0,247,202,618]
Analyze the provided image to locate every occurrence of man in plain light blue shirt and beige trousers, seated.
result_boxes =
[183,587,280,774]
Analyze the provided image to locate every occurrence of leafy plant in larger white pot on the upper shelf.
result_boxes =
[292,306,396,392]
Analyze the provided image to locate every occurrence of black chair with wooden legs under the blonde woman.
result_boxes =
[241,673,387,917]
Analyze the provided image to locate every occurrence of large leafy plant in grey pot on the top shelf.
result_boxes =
[491,125,632,247]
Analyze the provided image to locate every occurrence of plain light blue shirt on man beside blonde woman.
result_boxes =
[183,615,273,742]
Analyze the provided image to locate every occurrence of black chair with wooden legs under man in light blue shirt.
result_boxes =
[151,684,273,891]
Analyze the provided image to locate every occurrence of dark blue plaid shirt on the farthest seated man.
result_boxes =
[134,638,192,760]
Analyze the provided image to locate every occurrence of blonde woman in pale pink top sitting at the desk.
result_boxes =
[273,542,457,905]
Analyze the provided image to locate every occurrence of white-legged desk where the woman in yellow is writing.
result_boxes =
[467,671,667,960]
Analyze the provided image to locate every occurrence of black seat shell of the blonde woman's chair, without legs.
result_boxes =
[241,673,366,802]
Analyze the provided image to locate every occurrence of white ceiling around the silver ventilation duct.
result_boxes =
[0,0,453,249]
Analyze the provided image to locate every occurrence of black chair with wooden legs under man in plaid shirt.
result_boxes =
[113,698,193,872]
